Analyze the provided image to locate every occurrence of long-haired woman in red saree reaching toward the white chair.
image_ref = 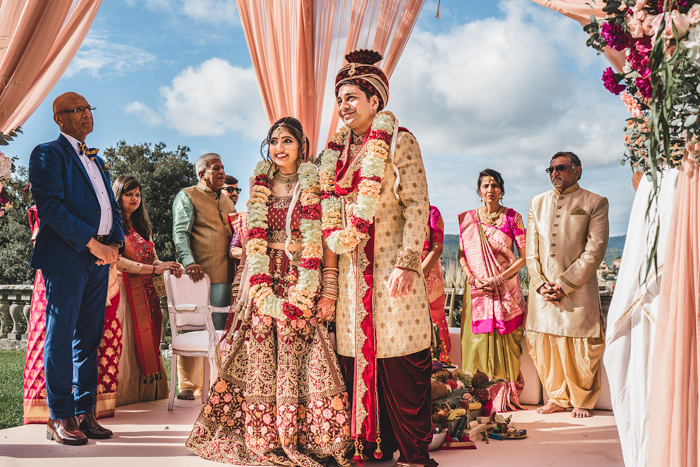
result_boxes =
[112,175,182,406]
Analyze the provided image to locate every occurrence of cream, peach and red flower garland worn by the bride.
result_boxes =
[246,161,323,321]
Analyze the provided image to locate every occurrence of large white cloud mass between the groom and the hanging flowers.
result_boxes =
[389,0,634,234]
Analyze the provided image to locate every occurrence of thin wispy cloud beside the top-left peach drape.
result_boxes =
[65,31,156,78]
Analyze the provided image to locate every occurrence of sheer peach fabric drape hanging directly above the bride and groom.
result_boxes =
[236,0,425,156]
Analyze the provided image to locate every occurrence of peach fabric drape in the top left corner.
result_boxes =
[0,0,102,133]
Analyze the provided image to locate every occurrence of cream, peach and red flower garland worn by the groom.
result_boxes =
[318,112,394,254]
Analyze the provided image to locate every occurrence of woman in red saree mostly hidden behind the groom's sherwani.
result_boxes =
[421,206,451,361]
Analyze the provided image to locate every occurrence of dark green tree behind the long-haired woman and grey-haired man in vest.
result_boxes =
[104,140,197,261]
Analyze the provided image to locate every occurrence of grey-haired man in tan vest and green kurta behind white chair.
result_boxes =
[173,153,236,399]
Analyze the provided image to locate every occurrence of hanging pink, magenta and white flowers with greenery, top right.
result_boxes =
[584,0,700,177]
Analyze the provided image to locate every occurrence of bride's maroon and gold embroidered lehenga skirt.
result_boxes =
[187,249,350,467]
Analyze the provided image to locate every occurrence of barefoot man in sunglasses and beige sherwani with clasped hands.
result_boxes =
[525,152,608,418]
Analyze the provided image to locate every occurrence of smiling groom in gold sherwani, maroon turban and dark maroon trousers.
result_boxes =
[319,50,435,466]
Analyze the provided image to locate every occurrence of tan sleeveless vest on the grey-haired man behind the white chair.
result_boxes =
[184,184,236,284]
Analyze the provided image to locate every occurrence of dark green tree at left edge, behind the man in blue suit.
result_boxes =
[0,167,34,285]
